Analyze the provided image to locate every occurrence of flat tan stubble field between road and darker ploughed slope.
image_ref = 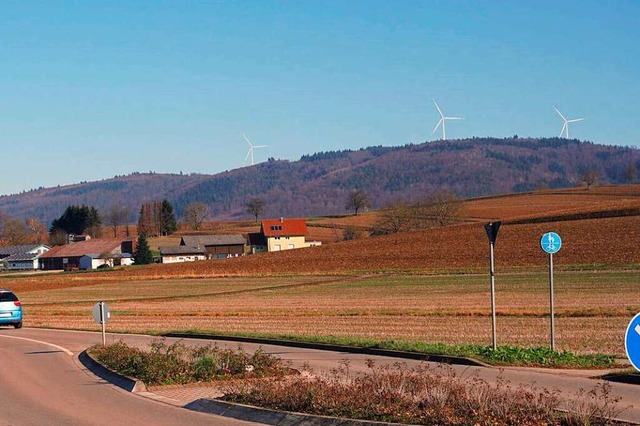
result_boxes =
[21,271,640,356]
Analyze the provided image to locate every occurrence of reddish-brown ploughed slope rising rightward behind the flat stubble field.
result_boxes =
[127,185,640,277]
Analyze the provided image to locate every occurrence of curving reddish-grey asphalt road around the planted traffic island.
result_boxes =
[0,328,640,425]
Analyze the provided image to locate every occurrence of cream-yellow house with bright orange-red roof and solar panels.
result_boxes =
[249,217,322,253]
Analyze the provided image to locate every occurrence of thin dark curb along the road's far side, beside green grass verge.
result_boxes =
[163,333,492,367]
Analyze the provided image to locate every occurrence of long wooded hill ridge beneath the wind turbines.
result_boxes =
[0,138,640,223]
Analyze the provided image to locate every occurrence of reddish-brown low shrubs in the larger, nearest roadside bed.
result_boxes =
[223,361,619,426]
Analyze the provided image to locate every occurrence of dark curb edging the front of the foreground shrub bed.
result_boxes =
[185,398,410,426]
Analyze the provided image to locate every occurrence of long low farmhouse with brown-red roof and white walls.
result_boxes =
[40,239,133,270]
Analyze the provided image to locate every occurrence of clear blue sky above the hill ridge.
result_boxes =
[0,0,640,194]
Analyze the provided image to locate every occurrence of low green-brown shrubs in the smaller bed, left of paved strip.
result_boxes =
[89,340,288,385]
